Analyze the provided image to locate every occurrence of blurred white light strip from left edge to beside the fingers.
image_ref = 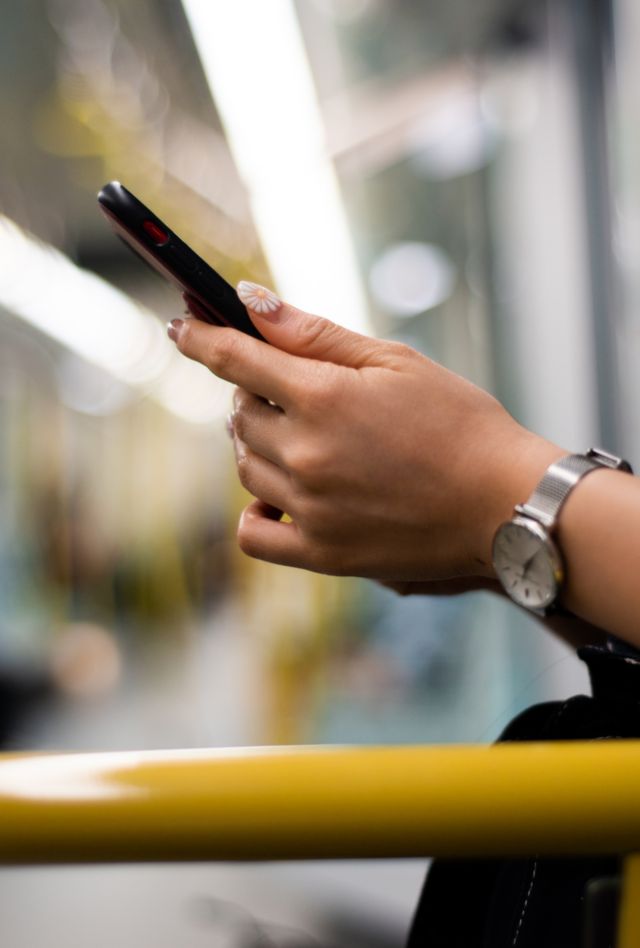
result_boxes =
[0,215,229,423]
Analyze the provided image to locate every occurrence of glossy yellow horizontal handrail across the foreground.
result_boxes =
[0,741,640,865]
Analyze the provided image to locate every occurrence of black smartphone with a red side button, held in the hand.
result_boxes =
[98,181,264,339]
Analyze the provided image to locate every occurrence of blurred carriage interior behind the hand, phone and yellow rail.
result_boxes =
[0,0,640,948]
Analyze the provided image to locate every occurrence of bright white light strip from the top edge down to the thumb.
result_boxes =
[183,0,369,332]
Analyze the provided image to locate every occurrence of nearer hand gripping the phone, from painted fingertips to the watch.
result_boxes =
[170,284,562,581]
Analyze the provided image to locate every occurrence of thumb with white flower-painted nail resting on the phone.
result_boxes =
[237,280,377,368]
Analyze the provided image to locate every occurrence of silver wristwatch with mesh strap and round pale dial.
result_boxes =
[493,448,633,615]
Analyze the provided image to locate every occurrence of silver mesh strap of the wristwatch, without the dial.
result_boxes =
[516,448,633,530]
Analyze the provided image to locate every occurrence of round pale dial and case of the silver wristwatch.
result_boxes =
[493,517,562,609]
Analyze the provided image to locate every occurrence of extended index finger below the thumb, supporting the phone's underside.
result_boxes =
[170,318,301,409]
